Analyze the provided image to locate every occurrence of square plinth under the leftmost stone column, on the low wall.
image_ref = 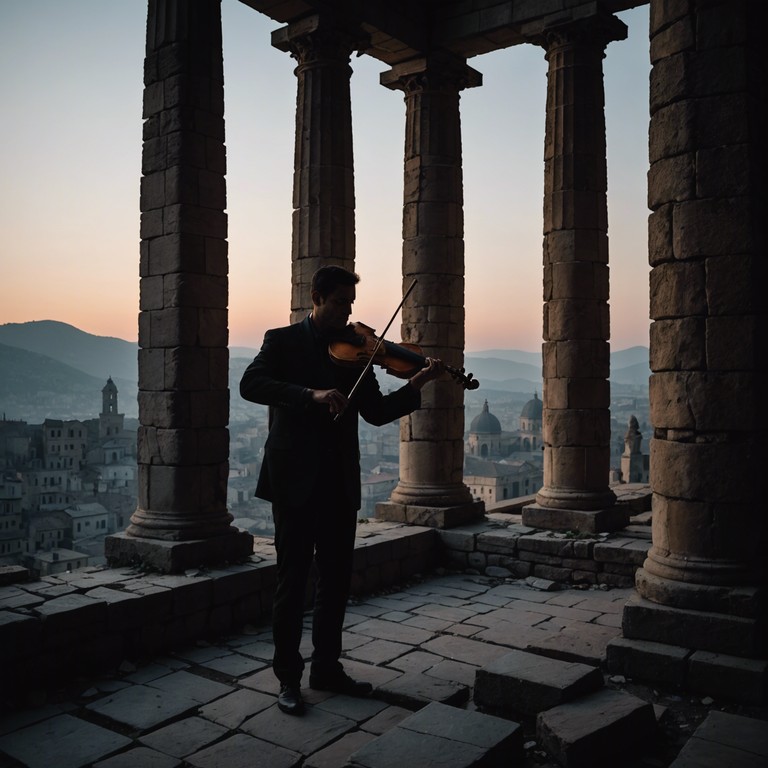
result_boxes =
[104,528,253,573]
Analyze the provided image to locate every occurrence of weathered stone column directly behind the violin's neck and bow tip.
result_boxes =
[376,51,484,527]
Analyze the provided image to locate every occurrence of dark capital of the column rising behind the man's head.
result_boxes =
[272,14,370,66]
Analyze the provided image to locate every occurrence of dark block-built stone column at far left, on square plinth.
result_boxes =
[106,0,253,572]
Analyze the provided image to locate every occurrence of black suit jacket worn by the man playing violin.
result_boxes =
[240,316,421,510]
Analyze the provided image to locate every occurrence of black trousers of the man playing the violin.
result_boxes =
[272,486,357,687]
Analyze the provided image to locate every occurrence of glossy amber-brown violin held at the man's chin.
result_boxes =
[328,323,480,389]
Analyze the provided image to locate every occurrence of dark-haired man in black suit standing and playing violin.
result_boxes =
[240,266,444,714]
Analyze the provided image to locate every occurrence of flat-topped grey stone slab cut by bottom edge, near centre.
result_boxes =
[347,702,523,768]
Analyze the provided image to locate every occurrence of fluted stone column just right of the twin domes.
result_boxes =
[523,16,628,532]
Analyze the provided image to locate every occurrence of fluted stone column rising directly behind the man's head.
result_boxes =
[272,16,367,322]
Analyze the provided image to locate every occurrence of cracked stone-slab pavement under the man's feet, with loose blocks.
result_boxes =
[0,573,768,768]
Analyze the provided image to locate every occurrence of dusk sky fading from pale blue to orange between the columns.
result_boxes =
[0,0,650,352]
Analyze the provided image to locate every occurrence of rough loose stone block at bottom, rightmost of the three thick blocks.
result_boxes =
[536,688,657,768]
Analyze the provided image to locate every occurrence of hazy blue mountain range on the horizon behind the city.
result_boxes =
[0,320,650,424]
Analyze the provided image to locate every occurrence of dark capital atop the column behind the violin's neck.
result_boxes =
[380,51,483,94]
